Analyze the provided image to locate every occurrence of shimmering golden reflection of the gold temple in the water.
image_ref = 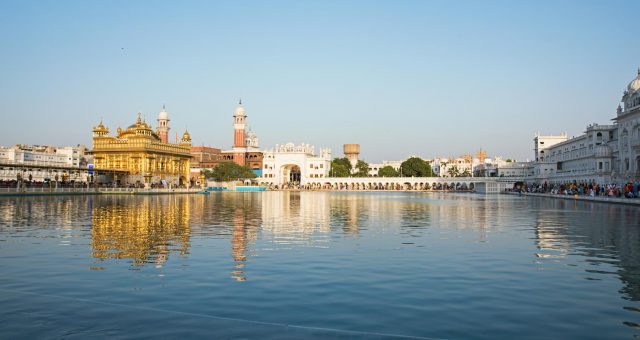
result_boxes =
[91,195,190,267]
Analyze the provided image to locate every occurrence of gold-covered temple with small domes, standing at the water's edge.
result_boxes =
[92,109,191,187]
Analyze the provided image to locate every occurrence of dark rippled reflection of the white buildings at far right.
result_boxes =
[533,199,640,301]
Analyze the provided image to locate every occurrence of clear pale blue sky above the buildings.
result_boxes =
[0,0,640,162]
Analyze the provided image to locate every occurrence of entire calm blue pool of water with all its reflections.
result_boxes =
[0,192,640,339]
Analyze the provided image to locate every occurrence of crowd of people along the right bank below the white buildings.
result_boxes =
[514,181,640,198]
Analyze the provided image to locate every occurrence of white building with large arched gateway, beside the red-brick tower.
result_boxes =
[259,143,331,186]
